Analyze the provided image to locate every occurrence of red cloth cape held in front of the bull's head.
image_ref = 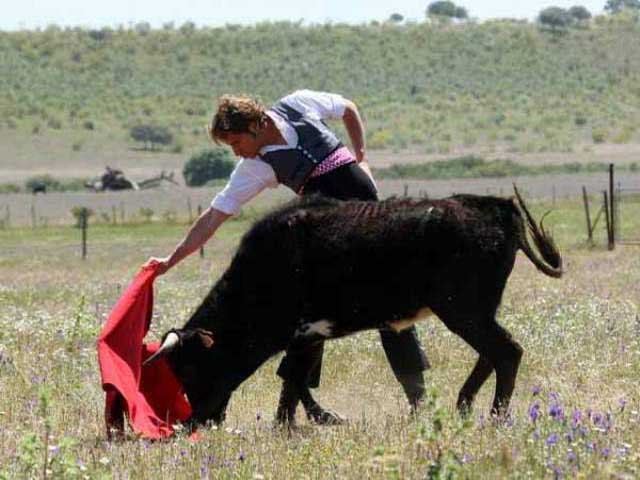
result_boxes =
[98,265,191,439]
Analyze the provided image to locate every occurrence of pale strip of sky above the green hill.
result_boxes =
[0,0,606,30]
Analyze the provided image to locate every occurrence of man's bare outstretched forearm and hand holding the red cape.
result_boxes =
[145,207,231,275]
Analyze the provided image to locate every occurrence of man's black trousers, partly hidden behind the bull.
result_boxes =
[278,163,429,388]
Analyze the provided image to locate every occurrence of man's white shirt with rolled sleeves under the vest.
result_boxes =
[211,90,346,215]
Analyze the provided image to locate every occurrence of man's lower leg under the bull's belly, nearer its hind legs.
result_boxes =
[380,327,429,409]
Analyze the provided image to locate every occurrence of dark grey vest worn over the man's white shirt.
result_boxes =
[260,101,342,193]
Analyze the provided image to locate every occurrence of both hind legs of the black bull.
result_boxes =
[448,317,523,415]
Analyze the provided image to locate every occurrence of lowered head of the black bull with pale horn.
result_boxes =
[143,328,240,424]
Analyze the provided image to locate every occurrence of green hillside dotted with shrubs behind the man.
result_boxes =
[0,16,640,153]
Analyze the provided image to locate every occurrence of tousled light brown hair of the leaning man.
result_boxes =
[209,95,265,143]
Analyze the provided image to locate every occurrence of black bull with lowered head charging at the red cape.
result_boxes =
[145,191,562,424]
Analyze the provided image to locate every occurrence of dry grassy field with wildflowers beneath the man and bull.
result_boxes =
[0,194,640,479]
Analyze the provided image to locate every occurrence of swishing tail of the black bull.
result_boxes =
[513,184,562,278]
